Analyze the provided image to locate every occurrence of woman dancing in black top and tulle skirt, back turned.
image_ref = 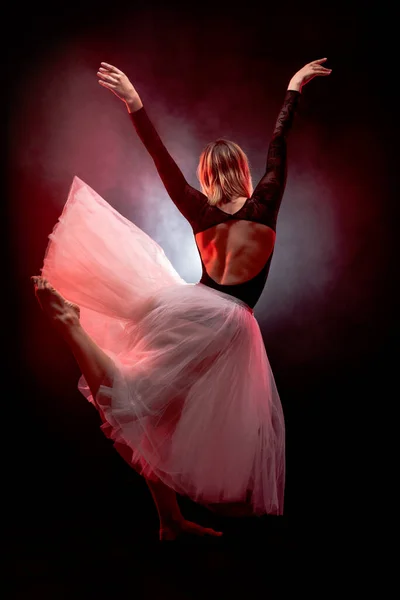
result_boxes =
[32,58,331,539]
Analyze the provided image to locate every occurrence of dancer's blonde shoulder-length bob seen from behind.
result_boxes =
[197,139,253,205]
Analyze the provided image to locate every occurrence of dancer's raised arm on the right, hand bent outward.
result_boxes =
[253,58,332,224]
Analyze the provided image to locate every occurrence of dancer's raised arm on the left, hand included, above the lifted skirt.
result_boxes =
[97,63,207,223]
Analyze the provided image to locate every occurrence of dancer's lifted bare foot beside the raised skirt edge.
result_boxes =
[31,276,80,328]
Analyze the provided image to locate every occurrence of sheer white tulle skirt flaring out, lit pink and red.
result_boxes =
[42,177,285,514]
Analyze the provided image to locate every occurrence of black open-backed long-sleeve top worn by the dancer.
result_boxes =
[131,90,300,308]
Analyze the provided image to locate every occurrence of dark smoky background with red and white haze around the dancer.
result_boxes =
[2,1,397,598]
